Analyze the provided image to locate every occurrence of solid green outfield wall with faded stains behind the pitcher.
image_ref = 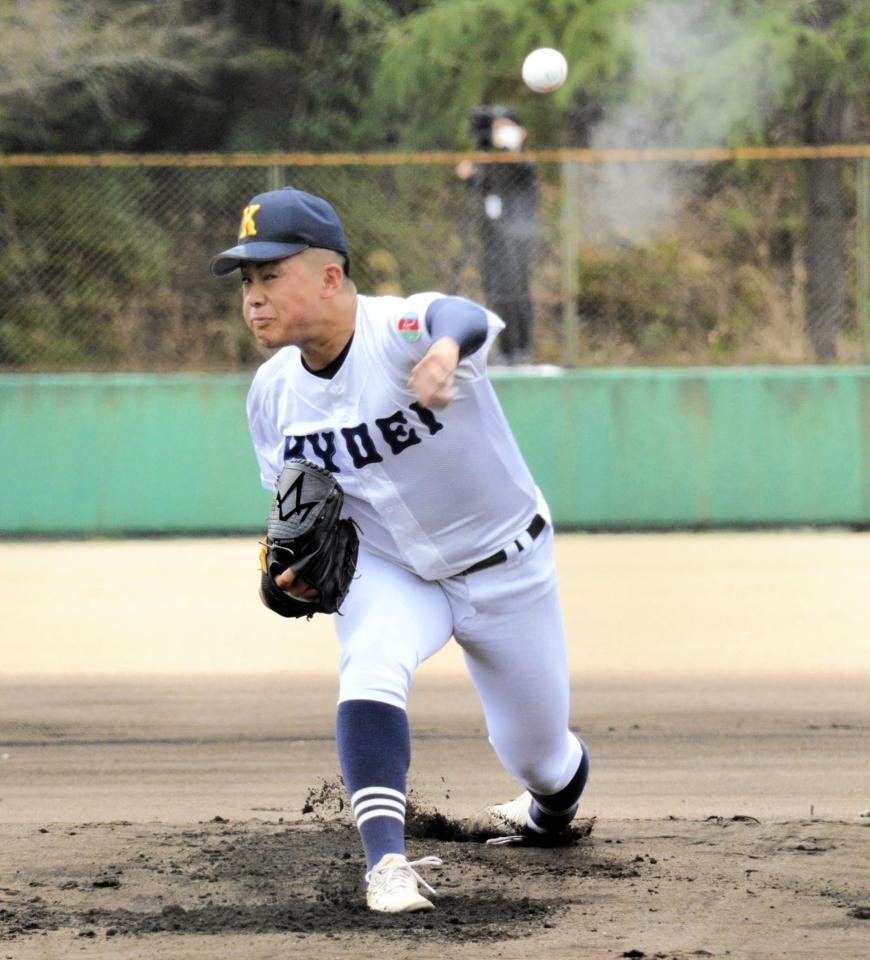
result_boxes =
[0,366,870,537]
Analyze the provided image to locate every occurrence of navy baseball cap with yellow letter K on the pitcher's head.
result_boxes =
[211,187,350,277]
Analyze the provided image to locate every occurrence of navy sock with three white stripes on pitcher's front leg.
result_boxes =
[335,700,411,870]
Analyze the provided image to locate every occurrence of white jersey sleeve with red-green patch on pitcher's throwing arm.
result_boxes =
[382,293,504,380]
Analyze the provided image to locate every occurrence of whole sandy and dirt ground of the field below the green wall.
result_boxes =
[0,532,870,960]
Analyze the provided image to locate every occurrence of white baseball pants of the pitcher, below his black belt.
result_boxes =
[334,525,582,795]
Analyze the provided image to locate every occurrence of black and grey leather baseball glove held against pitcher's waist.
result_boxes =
[260,459,359,620]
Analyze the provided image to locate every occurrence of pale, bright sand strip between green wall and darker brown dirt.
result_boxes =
[0,532,870,676]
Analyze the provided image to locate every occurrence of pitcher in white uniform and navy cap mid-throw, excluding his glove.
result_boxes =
[211,187,589,913]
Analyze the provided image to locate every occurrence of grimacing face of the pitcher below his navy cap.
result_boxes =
[241,253,321,348]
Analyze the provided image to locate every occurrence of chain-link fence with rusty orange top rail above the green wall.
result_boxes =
[0,147,870,371]
